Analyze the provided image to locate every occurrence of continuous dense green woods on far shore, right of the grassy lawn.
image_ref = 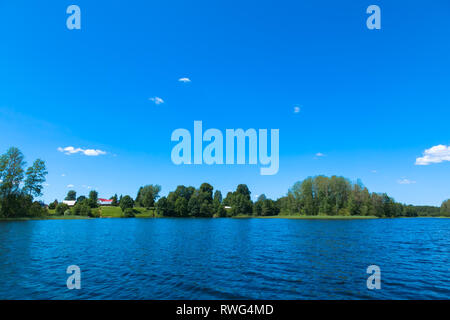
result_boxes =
[156,176,450,217]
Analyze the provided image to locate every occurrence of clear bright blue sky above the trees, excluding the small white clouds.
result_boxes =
[0,0,450,205]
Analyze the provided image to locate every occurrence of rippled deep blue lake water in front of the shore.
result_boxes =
[0,218,450,299]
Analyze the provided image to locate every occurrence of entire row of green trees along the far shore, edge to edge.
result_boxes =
[0,147,450,218]
